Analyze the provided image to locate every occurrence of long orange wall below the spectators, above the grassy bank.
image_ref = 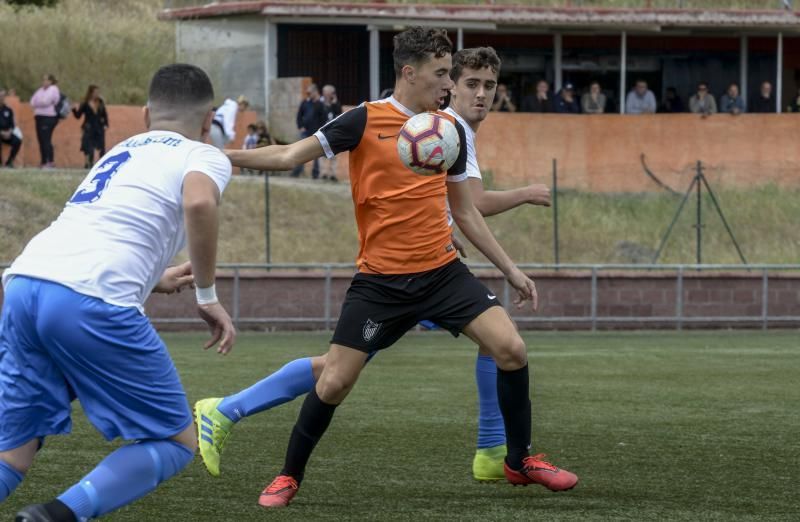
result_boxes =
[4,97,800,192]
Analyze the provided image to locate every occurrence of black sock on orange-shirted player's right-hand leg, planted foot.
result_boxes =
[497,364,531,470]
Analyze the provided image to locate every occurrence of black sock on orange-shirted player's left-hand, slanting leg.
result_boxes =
[281,387,337,482]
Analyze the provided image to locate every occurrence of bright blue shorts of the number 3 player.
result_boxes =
[0,276,192,451]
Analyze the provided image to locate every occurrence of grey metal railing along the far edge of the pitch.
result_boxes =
[0,263,800,330]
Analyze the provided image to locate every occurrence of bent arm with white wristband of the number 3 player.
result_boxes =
[183,172,236,354]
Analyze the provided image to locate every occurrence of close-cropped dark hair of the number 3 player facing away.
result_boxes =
[148,63,214,108]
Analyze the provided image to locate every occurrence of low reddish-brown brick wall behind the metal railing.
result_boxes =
[7,271,780,330]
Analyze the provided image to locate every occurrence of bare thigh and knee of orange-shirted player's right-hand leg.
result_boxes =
[464,306,528,370]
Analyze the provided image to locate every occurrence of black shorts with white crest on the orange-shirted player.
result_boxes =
[331,259,500,352]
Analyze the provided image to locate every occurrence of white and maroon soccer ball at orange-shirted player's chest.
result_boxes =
[397,112,461,176]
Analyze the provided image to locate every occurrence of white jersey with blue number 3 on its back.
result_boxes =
[3,131,231,312]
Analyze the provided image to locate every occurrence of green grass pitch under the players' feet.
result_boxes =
[0,331,800,522]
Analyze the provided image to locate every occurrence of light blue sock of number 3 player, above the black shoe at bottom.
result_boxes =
[58,440,194,521]
